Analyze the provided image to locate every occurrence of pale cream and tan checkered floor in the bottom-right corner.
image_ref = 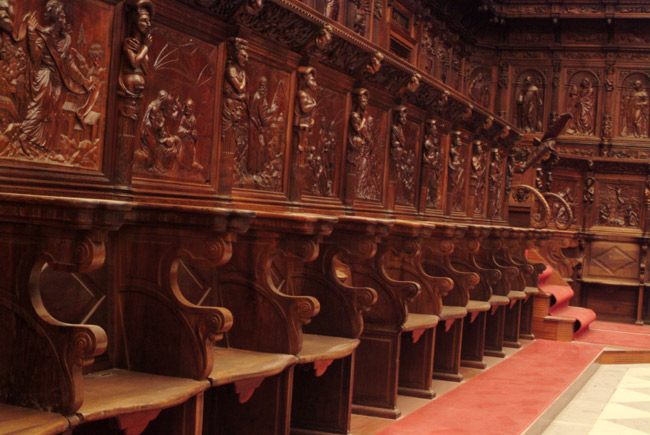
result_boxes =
[543,364,650,435]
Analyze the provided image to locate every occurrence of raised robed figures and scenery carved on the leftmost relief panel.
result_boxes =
[0,0,105,167]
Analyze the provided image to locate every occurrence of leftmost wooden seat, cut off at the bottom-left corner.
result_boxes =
[0,403,70,435]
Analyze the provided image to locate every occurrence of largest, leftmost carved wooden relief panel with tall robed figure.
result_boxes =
[0,0,113,170]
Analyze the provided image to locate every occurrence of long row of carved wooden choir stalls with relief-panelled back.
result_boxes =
[0,0,612,434]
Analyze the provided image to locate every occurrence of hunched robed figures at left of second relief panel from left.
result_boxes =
[134,90,183,174]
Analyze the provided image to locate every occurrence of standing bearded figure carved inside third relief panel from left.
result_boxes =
[248,76,284,173]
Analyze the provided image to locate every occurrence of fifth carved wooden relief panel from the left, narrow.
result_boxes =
[356,105,387,201]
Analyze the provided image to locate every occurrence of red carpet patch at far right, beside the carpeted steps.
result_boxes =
[574,322,650,349]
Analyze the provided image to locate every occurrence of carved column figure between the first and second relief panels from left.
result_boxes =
[119,0,153,110]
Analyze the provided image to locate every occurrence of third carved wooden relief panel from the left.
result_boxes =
[229,53,290,191]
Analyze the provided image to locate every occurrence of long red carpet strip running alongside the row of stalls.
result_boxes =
[380,340,603,435]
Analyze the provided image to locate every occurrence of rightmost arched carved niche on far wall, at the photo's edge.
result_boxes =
[619,72,650,137]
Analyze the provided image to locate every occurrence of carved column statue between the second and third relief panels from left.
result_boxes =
[221,38,248,152]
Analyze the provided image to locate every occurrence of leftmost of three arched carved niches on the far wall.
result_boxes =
[513,69,546,133]
